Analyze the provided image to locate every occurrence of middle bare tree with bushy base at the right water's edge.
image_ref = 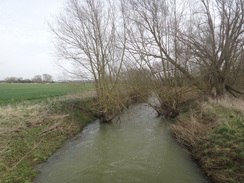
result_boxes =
[120,0,198,117]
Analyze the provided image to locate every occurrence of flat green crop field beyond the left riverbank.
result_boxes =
[0,83,93,104]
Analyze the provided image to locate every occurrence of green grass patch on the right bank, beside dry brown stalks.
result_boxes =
[201,104,244,183]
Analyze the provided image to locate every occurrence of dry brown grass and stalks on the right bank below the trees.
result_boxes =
[171,97,244,149]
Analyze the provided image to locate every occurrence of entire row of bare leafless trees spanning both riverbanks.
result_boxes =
[51,0,244,120]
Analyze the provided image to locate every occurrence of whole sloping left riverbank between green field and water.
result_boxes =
[0,97,95,183]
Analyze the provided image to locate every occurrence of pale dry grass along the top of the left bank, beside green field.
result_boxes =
[0,103,72,160]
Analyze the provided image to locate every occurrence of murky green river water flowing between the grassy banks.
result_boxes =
[34,104,208,183]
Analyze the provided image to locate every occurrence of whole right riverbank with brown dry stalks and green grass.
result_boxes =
[171,97,244,183]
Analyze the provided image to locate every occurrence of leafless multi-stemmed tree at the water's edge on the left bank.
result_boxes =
[51,0,126,121]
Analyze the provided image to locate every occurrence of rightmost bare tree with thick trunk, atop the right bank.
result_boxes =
[180,0,244,96]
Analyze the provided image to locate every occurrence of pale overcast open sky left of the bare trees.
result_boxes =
[0,0,66,80]
